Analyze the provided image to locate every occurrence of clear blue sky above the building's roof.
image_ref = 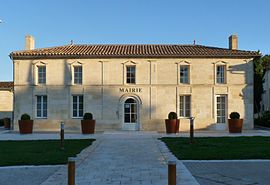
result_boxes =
[0,0,270,81]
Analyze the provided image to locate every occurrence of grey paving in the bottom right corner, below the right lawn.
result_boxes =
[184,160,270,185]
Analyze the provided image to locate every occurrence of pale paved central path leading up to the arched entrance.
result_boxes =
[43,132,197,185]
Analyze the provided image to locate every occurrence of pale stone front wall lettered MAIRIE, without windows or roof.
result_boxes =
[13,58,253,131]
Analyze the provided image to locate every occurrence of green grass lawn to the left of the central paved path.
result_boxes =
[0,139,94,166]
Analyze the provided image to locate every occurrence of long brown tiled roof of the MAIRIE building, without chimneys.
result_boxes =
[10,44,260,59]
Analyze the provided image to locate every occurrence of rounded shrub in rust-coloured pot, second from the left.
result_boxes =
[81,113,96,134]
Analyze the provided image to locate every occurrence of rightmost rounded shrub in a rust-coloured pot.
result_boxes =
[228,112,243,133]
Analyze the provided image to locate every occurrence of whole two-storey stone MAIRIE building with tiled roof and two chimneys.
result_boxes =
[10,35,259,131]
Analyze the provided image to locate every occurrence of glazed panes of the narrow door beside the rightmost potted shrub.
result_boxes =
[216,95,226,123]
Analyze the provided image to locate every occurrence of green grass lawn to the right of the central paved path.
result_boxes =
[160,136,270,160]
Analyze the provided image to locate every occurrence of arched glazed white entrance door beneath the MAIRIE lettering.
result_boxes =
[123,98,138,130]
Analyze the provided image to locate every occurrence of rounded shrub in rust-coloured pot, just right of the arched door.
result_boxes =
[165,112,180,134]
